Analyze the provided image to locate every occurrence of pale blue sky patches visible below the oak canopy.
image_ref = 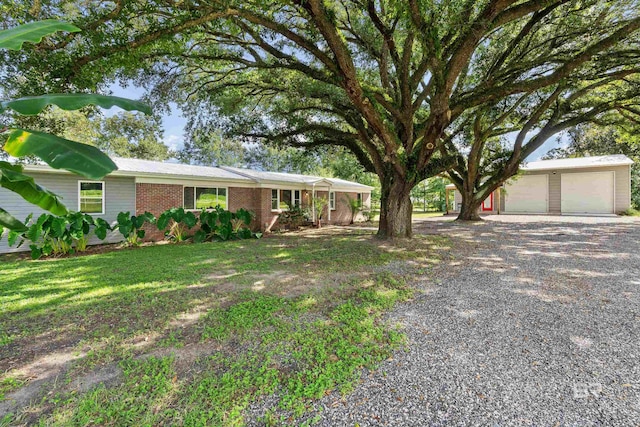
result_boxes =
[110,85,564,161]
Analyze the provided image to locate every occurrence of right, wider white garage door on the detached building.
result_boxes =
[560,172,614,214]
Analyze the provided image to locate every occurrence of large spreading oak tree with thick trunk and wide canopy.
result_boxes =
[5,0,640,237]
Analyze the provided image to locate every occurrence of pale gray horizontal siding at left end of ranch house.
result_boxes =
[0,172,136,253]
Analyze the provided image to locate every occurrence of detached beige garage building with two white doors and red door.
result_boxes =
[447,154,633,215]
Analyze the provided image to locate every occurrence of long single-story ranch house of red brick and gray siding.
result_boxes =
[0,158,372,253]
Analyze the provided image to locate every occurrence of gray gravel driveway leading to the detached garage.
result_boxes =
[318,216,640,426]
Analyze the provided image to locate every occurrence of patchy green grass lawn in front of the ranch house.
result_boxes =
[0,228,446,426]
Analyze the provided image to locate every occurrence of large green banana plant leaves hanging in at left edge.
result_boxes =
[0,19,151,237]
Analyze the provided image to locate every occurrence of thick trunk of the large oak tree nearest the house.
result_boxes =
[378,178,413,239]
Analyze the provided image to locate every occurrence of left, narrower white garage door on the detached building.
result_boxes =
[504,175,549,213]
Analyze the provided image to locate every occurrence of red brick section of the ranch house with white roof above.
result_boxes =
[125,159,371,240]
